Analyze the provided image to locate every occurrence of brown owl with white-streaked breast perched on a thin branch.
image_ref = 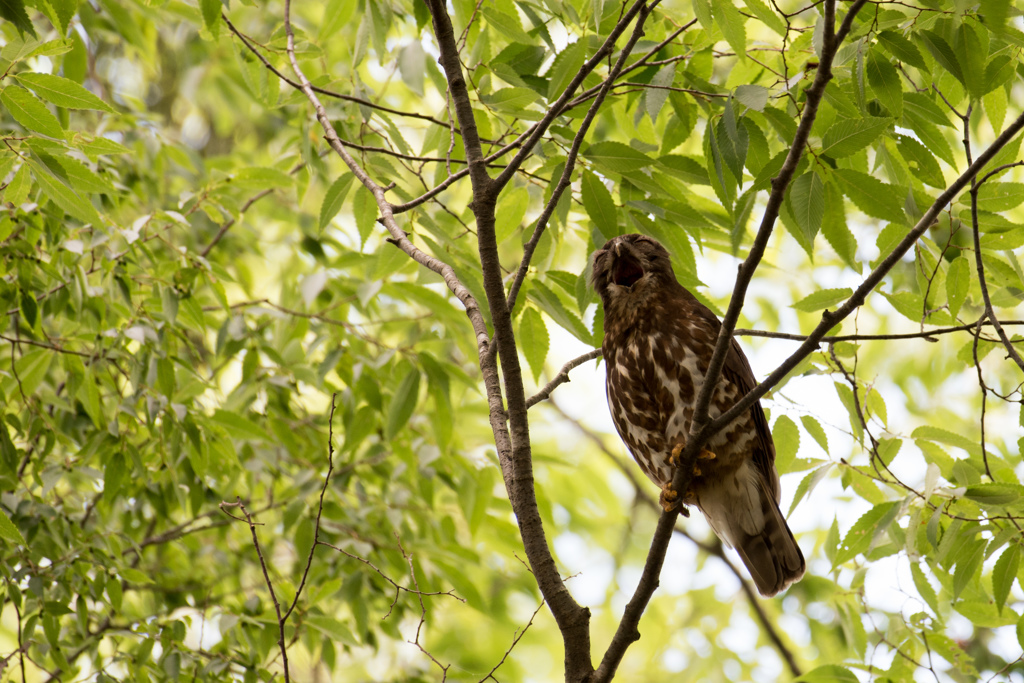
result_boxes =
[592,234,805,597]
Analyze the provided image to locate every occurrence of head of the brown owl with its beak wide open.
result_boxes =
[591,234,676,315]
